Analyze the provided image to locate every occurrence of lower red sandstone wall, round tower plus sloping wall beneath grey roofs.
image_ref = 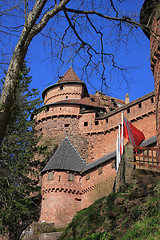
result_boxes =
[40,162,116,227]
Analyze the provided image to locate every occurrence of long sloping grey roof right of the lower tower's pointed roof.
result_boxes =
[82,151,116,173]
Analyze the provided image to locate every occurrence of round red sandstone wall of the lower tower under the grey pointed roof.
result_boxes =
[40,171,81,227]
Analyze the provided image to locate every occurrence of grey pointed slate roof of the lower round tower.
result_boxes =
[42,137,86,173]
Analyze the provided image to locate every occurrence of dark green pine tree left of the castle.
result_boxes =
[0,64,41,240]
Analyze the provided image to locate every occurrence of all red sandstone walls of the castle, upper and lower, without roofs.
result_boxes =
[36,66,156,227]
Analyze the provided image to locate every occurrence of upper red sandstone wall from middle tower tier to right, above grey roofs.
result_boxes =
[37,92,156,162]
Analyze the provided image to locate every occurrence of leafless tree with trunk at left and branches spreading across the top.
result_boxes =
[0,0,146,142]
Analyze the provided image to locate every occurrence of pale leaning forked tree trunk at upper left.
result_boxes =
[0,0,70,143]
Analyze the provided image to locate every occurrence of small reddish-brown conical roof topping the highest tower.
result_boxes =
[58,67,81,83]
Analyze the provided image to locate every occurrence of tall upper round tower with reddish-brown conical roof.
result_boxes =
[35,68,105,162]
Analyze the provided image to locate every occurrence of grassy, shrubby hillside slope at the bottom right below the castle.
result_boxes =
[60,182,160,240]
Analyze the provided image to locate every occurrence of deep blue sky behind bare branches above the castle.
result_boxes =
[0,0,154,101]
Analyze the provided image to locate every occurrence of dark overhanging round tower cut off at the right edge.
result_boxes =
[140,0,160,147]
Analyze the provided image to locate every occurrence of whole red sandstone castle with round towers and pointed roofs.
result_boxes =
[35,68,156,227]
